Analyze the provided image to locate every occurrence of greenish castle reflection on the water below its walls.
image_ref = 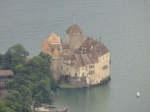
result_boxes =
[54,83,110,112]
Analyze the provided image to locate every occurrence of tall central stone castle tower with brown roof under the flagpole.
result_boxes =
[66,24,83,50]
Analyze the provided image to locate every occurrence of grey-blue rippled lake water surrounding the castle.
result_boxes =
[0,0,150,112]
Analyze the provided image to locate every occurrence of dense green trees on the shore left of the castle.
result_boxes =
[0,44,58,112]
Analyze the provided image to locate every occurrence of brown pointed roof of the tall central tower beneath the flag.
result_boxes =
[66,24,83,34]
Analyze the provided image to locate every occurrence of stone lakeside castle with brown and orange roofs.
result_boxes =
[41,24,110,87]
